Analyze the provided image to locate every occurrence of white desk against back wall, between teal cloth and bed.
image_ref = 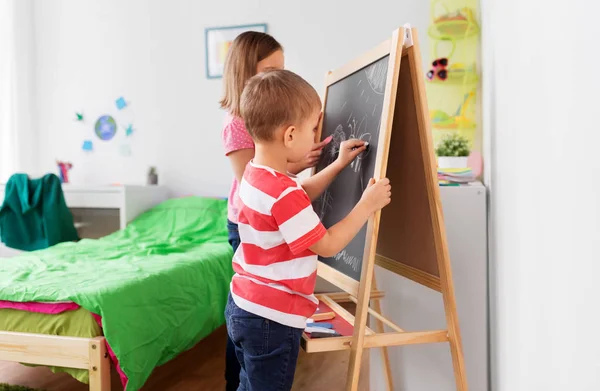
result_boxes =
[0,184,168,237]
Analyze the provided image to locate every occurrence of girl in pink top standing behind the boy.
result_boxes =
[220,31,331,391]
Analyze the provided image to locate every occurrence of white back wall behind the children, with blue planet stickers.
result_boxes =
[35,0,428,196]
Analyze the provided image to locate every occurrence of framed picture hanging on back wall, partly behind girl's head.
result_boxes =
[205,23,267,79]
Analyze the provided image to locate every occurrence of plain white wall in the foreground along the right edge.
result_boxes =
[482,0,600,391]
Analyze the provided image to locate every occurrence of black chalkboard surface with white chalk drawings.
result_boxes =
[313,55,389,281]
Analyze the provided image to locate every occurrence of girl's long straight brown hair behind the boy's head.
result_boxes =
[220,31,283,117]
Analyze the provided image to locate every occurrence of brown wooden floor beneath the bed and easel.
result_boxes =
[0,327,369,391]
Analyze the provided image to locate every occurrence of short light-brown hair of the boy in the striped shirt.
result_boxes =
[240,70,321,141]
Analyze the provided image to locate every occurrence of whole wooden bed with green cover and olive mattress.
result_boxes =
[0,197,233,391]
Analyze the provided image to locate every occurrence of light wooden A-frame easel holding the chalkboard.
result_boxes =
[302,28,468,391]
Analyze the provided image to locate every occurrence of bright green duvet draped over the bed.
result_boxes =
[0,197,233,391]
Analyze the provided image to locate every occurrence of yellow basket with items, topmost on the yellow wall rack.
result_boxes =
[428,1,479,39]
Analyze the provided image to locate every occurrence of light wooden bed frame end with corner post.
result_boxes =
[0,331,110,391]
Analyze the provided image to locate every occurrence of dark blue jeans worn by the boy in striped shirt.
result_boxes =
[225,294,302,391]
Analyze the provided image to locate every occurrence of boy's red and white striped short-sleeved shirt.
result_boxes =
[231,162,326,329]
